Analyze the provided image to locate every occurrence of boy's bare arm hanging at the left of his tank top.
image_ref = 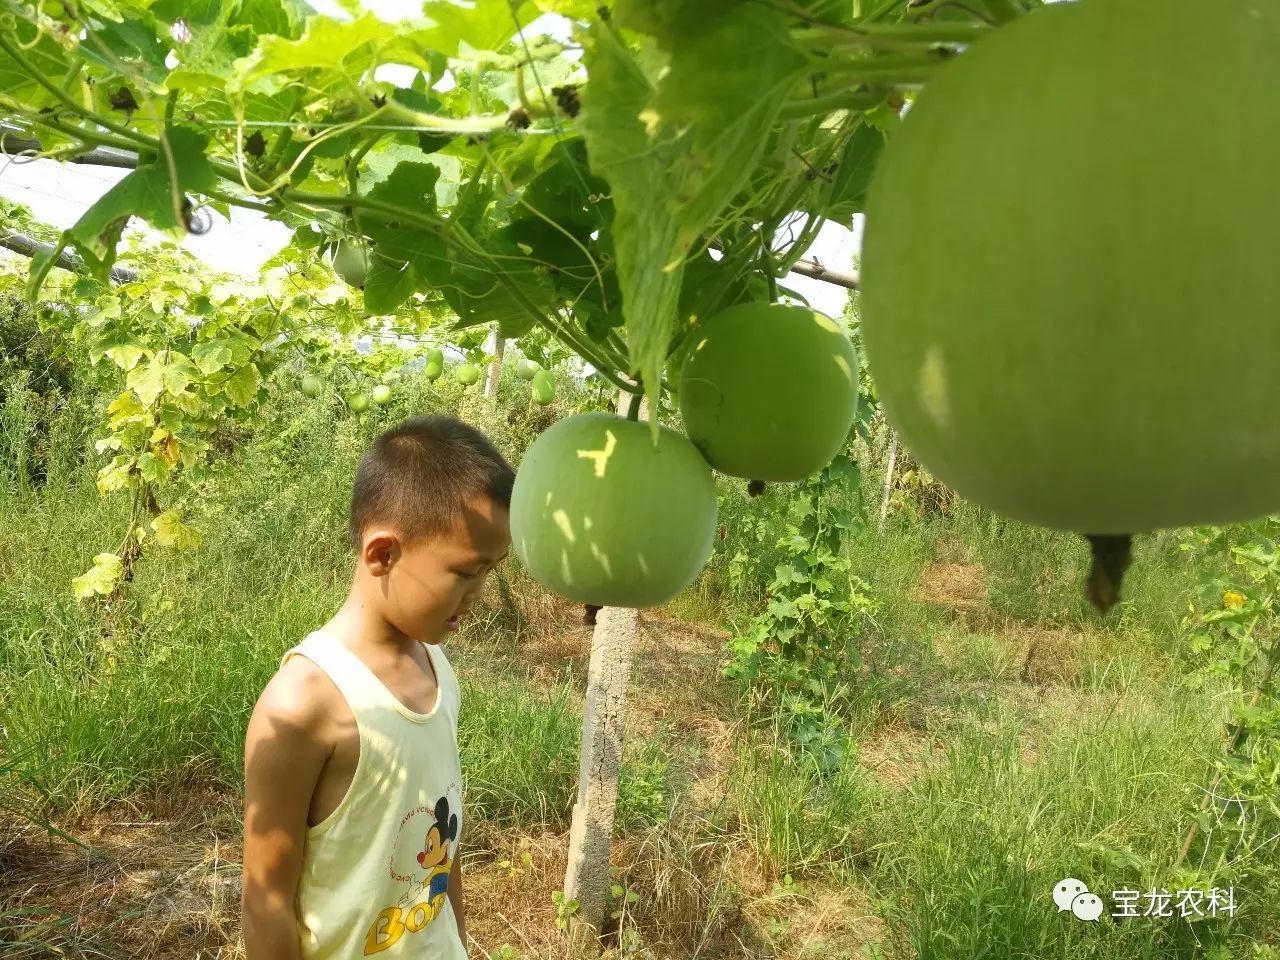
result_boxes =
[241,659,329,960]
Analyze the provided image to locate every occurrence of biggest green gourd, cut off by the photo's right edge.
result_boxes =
[861,0,1280,534]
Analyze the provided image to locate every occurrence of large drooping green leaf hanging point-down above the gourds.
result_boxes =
[581,6,806,414]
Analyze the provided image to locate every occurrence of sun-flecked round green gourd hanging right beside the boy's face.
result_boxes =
[511,413,716,608]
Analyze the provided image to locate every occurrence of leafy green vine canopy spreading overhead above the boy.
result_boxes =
[0,0,1009,407]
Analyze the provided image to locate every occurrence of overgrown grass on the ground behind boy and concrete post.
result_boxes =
[0,378,1280,960]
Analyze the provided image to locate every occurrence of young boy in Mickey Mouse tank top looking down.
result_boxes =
[242,416,515,960]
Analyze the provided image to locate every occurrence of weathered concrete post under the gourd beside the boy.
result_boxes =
[564,393,649,954]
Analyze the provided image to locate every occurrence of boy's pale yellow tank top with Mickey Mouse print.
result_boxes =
[280,631,467,960]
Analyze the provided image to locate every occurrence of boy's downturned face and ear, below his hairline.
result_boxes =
[364,494,511,644]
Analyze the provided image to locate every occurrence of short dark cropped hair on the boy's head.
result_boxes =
[347,415,516,553]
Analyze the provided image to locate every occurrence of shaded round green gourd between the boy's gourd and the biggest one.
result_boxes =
[680,303,858,483]
